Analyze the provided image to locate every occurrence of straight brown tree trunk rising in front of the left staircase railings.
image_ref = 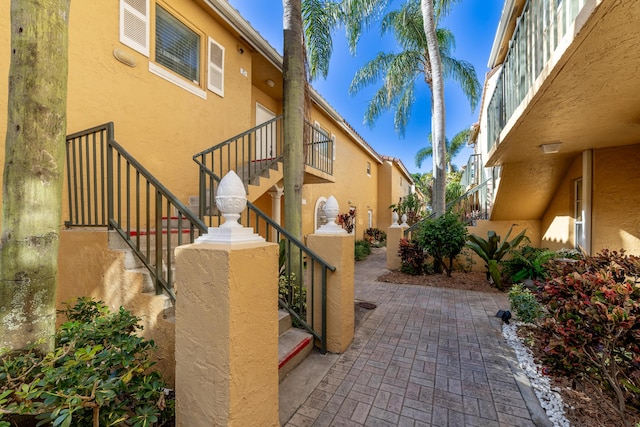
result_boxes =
[282,0,307,240]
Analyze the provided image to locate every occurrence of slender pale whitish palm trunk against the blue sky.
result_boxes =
[421,0,447,216]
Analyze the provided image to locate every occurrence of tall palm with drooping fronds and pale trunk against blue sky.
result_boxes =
[349,0,481,217]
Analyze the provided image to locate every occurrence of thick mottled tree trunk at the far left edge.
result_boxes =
[0,0,69,351]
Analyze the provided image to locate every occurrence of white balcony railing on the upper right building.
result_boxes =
[487,0,585,151]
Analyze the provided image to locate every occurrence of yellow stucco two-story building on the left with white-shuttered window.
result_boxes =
[0,0,418,234]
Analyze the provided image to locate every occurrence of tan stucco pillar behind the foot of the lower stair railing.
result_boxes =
[307,233,355,353]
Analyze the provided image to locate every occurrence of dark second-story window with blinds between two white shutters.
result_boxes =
[155,6,200,84]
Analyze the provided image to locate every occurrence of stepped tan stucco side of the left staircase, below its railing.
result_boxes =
[57,229,175,384]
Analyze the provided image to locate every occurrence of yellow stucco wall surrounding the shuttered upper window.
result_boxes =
[0,0,262,227]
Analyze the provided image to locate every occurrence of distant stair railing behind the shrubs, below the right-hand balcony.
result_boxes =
[404,179,491,238]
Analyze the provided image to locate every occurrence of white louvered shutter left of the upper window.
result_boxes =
[120,0,149,57]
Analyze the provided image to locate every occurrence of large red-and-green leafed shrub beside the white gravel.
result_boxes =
[540,251,640,424]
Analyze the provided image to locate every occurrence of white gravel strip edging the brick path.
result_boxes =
[502,322,571,427]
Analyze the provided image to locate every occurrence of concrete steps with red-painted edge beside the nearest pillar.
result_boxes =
[278,310,313,381]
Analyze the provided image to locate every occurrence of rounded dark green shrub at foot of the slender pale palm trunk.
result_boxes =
[417,212,467,276]
